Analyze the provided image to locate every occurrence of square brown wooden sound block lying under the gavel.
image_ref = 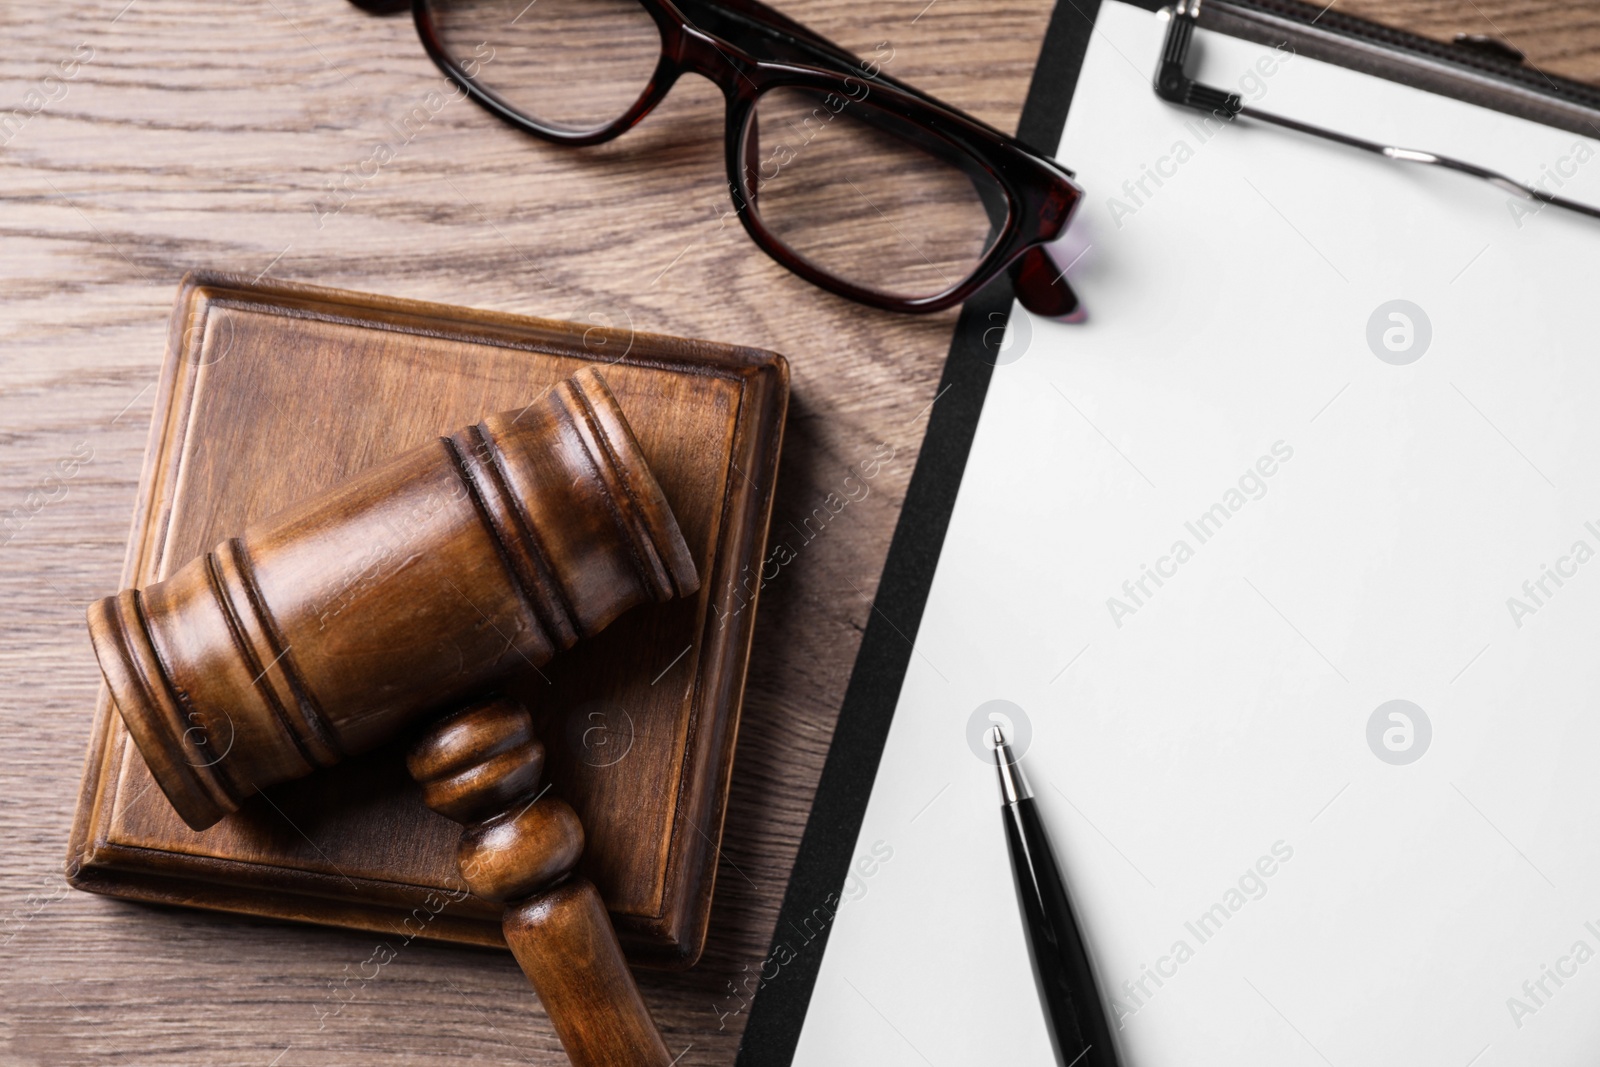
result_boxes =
[69,274,789,966]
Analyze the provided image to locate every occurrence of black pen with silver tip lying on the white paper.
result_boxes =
[989,726,1117,1067]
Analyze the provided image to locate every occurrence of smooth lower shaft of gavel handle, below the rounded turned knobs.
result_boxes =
[504,877,672,1067]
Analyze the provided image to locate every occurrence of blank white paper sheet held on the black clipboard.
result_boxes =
[795,0,1600,1067]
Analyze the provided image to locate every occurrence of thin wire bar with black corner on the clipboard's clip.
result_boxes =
[1155,0,1600,219]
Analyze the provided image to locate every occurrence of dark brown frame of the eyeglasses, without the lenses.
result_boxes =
[409,0,1083,317]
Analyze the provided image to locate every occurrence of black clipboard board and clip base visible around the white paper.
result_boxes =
[736,0,1600,1067]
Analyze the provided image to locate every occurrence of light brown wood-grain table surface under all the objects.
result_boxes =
[0,0,1600,1067]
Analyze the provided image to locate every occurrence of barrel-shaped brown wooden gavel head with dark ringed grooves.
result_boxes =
[88,370,699,830]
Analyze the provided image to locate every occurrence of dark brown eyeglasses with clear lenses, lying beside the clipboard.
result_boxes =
[385,0,1082,317]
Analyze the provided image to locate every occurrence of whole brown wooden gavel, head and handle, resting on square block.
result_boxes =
[88,368,699,1067]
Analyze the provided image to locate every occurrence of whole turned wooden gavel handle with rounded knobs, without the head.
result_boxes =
[406,697,674,1067]
